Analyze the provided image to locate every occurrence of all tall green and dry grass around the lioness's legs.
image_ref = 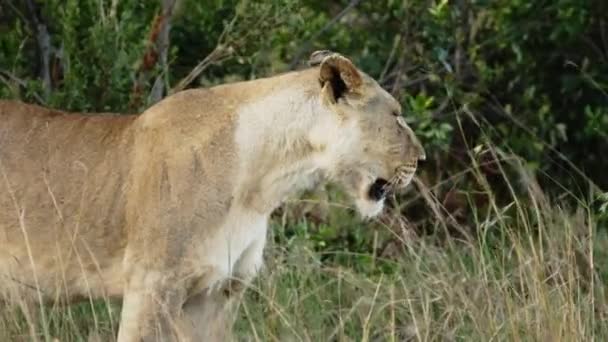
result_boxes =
[0,147,608,342]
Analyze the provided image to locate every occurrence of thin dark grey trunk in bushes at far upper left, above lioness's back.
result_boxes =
[25,0,52,98]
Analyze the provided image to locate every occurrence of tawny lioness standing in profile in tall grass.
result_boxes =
[0,51,425,342]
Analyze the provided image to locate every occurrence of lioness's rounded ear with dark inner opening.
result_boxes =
[309,51,363,103]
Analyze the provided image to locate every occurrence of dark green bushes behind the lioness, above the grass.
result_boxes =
[0,0,608,243]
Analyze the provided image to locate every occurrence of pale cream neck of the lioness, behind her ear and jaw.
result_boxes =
[235,87,346,214]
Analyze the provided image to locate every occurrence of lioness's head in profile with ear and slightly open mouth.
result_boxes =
[309,51,426,217]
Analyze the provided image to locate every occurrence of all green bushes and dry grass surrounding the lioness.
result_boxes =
[0,0,608,341]
